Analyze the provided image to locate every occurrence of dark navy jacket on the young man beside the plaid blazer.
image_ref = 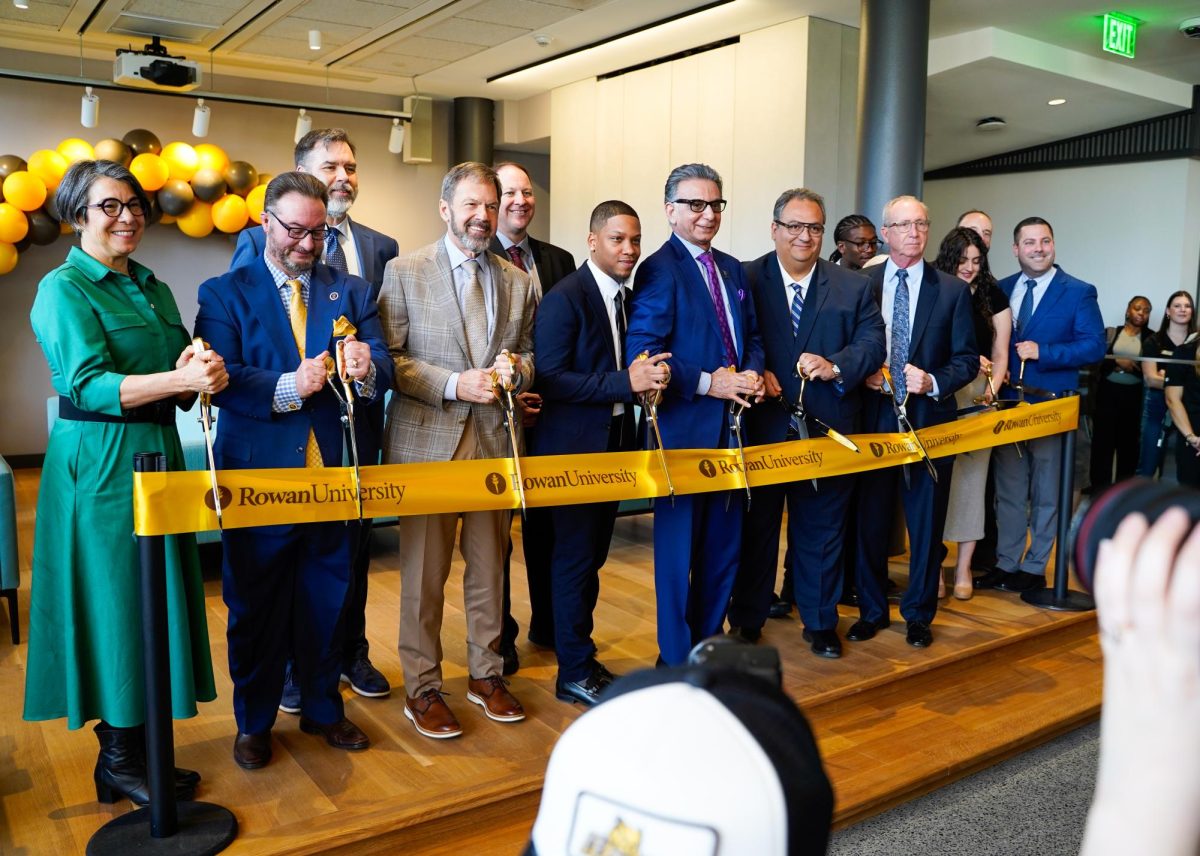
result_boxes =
[532,263,634,455]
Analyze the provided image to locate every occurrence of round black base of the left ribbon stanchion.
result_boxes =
[88,802,238,856]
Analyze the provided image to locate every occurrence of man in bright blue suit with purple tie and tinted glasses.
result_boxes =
[625,163,763,666]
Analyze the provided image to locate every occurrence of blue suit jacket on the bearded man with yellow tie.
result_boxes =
[196,259,392,469]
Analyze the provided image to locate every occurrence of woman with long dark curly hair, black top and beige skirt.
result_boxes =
[934,228,1013,600]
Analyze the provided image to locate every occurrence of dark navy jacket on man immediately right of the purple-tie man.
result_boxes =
[743,251,887,443]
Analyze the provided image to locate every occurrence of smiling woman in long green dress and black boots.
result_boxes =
[24,161,228,804]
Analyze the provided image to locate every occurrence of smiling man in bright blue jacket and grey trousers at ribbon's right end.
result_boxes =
[976,217,1105,592]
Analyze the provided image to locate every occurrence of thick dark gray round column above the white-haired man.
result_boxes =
[856,0,929,226]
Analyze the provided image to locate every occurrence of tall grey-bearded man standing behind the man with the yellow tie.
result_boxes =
[229,127,400,713]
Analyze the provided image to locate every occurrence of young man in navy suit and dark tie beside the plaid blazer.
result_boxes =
[532,200,670,706]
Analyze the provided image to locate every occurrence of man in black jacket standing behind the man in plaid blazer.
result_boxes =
[490,161,575,675]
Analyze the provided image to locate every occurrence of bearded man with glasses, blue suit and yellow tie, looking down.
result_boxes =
[196,172,392,770]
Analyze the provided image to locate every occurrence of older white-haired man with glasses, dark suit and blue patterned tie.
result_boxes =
[846,196,979,648]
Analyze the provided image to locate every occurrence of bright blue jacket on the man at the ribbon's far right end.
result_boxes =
[1000,265,1105,400]
